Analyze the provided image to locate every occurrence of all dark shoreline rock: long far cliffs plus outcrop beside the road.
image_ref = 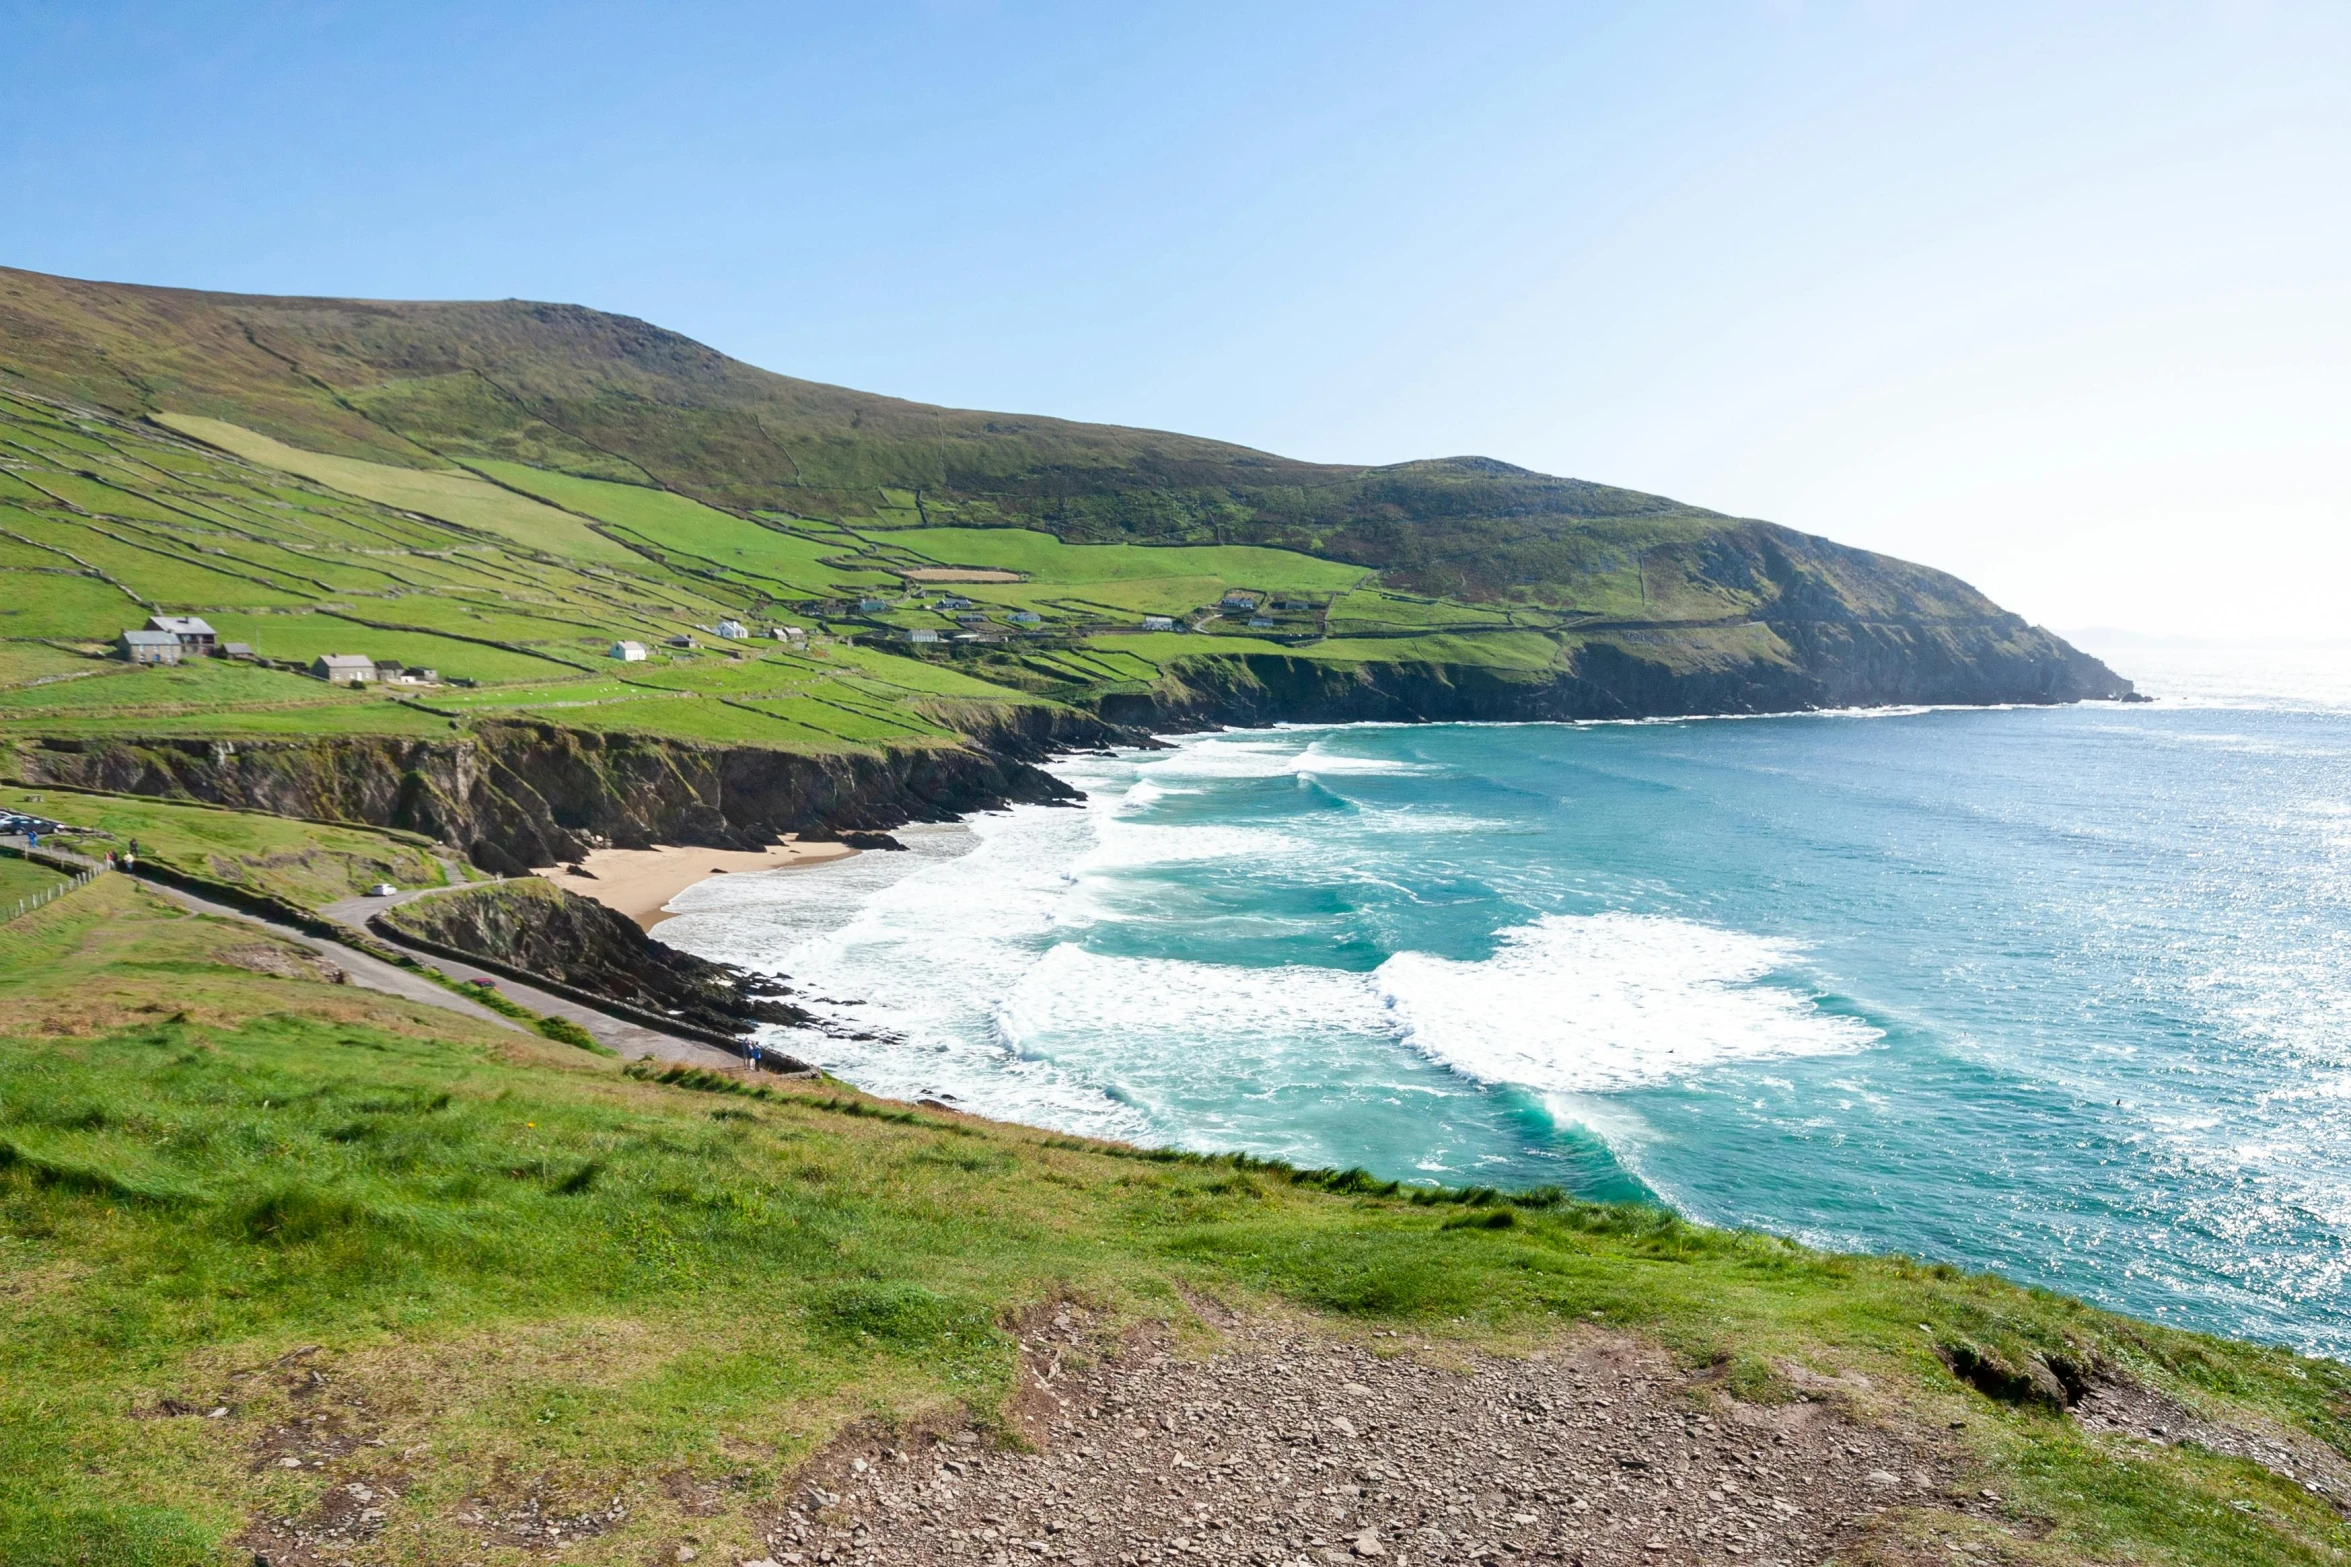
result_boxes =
[12,648,2132,1052]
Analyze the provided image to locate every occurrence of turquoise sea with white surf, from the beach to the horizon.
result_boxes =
[663,653,2351,1353]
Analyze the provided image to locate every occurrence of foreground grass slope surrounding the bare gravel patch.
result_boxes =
[0,879,2351,1565]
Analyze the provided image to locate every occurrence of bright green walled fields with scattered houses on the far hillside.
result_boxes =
[0,395,1702,749]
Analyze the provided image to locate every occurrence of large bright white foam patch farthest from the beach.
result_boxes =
[1375,914,1878,1092]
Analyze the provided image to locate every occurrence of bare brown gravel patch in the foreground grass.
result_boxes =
[747,1318,2003,1567]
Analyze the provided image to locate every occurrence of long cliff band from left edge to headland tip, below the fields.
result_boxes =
[9,616,2130,876]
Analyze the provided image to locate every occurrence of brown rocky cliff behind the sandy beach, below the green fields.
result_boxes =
[12,709,1100,874]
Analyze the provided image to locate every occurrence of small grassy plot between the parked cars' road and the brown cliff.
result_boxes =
[0,785,447,907]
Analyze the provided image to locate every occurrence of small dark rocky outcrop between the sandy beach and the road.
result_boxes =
[381,876,809,1034]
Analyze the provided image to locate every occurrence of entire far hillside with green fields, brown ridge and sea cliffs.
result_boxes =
[0,270,2130,869]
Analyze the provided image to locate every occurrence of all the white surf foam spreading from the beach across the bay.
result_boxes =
[663,731,1876,1174]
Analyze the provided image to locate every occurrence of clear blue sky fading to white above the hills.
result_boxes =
[0,0,2351,634]
